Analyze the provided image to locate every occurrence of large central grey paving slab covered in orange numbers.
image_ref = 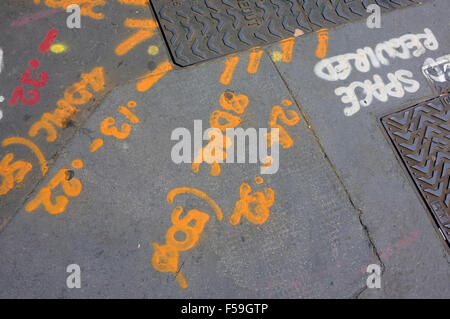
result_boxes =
[0,49,375,298]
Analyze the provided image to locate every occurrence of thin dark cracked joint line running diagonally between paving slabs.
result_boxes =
[266,49,386,274]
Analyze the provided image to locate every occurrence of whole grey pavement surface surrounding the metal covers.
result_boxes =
[0,0,450,298]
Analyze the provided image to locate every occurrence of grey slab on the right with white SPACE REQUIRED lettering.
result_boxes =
[269,1,450,298]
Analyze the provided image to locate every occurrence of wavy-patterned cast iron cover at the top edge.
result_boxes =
[150,0,429,66]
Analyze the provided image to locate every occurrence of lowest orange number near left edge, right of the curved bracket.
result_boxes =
[25,165,83,215]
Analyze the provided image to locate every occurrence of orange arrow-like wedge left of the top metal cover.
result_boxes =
[116,18,158,56]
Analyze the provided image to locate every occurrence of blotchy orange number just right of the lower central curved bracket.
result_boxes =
[229,183,275,225]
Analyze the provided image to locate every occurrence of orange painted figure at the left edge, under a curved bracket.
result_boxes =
[0,153,33,195]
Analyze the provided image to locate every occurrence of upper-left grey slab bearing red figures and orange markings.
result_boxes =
[0,0,168,229]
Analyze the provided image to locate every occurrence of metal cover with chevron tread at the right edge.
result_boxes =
[381,95,450,248]
